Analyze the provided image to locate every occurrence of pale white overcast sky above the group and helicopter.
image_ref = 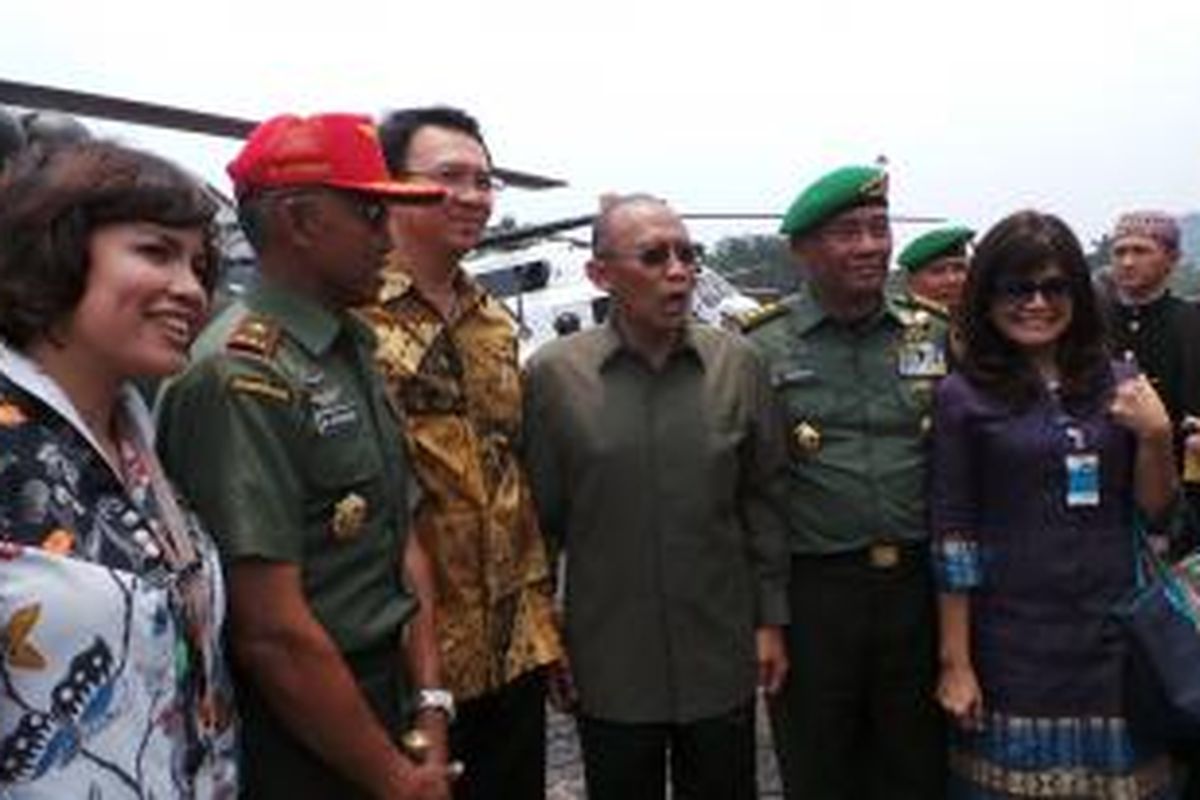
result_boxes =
[0,0,1200,250]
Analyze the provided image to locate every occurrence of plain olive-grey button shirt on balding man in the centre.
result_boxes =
[526,323,788,722]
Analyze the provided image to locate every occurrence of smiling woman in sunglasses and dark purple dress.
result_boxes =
[931,211,1176,799]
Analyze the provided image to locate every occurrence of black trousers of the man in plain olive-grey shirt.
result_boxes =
[578,700,757,800]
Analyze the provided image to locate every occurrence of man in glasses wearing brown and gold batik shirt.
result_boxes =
[365,108,560,800]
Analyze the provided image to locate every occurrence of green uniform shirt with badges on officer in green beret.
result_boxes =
[744,288,947,554]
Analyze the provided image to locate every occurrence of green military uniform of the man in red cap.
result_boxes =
[158,280,416,796]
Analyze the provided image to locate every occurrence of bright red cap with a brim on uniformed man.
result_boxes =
[226,114,445,203]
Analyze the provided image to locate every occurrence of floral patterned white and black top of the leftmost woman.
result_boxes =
[0,348,238,800]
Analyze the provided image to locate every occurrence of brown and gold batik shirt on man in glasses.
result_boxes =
[362,260,562,699]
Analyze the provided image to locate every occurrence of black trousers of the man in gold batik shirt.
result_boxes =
[450,669,546,800]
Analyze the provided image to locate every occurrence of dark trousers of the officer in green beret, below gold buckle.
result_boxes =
[770,546,946,800]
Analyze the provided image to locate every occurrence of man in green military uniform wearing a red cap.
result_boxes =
[157,114,451,800]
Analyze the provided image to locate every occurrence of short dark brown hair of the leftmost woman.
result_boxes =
[0,140,217,349]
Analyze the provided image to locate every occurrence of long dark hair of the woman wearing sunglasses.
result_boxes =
[956,210,1110,409]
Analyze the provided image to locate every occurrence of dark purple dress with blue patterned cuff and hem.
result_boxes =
[931,374,1172,799]
